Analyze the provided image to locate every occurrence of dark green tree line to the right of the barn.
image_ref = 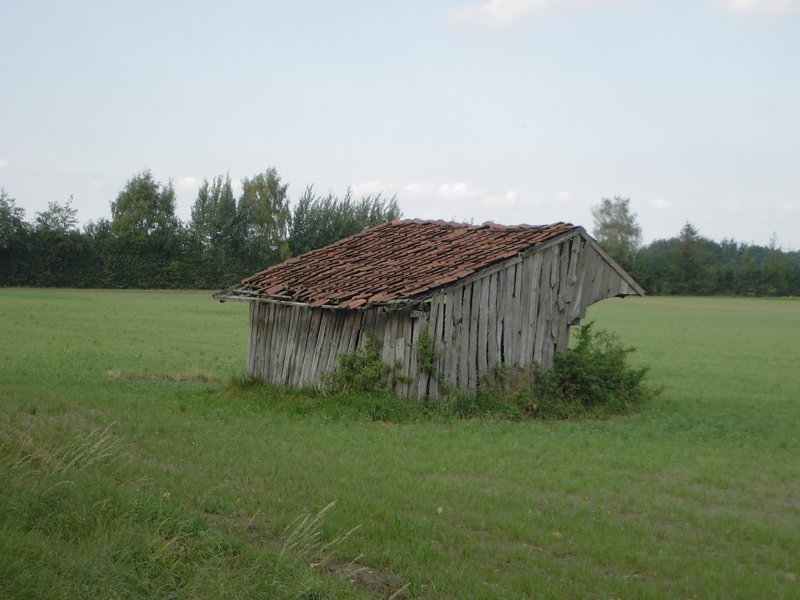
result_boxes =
[592,196,800,296]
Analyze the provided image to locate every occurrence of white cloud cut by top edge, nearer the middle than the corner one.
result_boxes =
[448,0,632,28]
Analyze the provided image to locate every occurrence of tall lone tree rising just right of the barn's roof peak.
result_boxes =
[592,196,642,269]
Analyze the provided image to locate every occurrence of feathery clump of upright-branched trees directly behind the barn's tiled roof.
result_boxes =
[289,187,401,256]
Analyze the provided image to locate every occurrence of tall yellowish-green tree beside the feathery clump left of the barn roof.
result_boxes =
[237,168,291,270]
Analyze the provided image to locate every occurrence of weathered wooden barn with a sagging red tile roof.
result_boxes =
[214,220,644,398]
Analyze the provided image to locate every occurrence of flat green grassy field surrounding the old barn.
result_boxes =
[0,289,800,599]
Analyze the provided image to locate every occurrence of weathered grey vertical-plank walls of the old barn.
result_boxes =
[248,235,641,398]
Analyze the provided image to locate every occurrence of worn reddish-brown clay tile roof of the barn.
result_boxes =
[238,220,579,308]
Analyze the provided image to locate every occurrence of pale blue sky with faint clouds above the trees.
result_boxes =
[0,0,800,250]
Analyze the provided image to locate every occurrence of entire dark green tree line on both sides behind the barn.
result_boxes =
[0,180,800,296]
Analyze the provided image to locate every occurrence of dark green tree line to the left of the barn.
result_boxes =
[0,168,401,289]
